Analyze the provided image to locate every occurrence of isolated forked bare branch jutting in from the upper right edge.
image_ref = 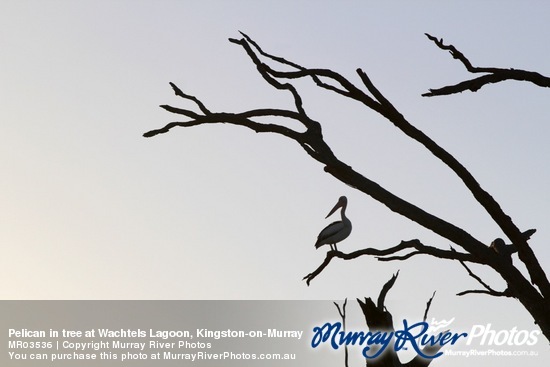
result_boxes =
[422,33,550,97]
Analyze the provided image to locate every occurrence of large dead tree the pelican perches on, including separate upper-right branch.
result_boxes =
[144,33,550,340]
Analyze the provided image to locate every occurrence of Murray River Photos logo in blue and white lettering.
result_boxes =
[311,318,540,359]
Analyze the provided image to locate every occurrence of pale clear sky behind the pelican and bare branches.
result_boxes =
[0,0,550,366]
